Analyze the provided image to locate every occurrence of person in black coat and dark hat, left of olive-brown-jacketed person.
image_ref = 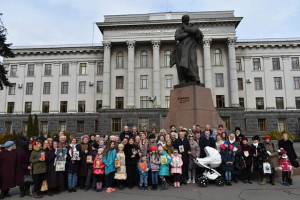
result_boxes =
[251,135,269,185]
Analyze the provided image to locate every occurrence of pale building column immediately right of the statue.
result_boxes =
[203,38,212,89]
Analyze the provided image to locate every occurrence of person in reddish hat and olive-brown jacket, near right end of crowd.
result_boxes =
[264,135,278,185]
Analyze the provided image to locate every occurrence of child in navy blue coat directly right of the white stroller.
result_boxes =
[220,141,235,186]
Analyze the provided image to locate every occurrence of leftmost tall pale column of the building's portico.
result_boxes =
[102,42,111,109]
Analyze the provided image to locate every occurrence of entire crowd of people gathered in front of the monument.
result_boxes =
[0,125,298,199]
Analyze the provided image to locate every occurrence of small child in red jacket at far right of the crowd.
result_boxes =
[279,148,292,186]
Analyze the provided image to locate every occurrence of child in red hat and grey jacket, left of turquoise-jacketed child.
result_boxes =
[149,145,161,190]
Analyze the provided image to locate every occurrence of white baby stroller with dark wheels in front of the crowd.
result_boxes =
[193,147,224,187]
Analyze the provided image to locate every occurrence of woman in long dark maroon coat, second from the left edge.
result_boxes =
[16,137,32,198]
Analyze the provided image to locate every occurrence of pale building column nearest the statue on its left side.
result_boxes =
[152,40,160,107]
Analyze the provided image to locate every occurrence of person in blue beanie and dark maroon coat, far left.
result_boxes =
[0,141,17,199]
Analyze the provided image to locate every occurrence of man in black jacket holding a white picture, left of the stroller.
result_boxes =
[173,129,191,184]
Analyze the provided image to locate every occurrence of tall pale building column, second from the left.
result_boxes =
[126,41,135,108]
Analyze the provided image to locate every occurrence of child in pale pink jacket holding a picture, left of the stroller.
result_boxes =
[170,149,183,188]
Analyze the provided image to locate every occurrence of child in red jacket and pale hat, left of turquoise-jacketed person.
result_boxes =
[93,148,105,192]
